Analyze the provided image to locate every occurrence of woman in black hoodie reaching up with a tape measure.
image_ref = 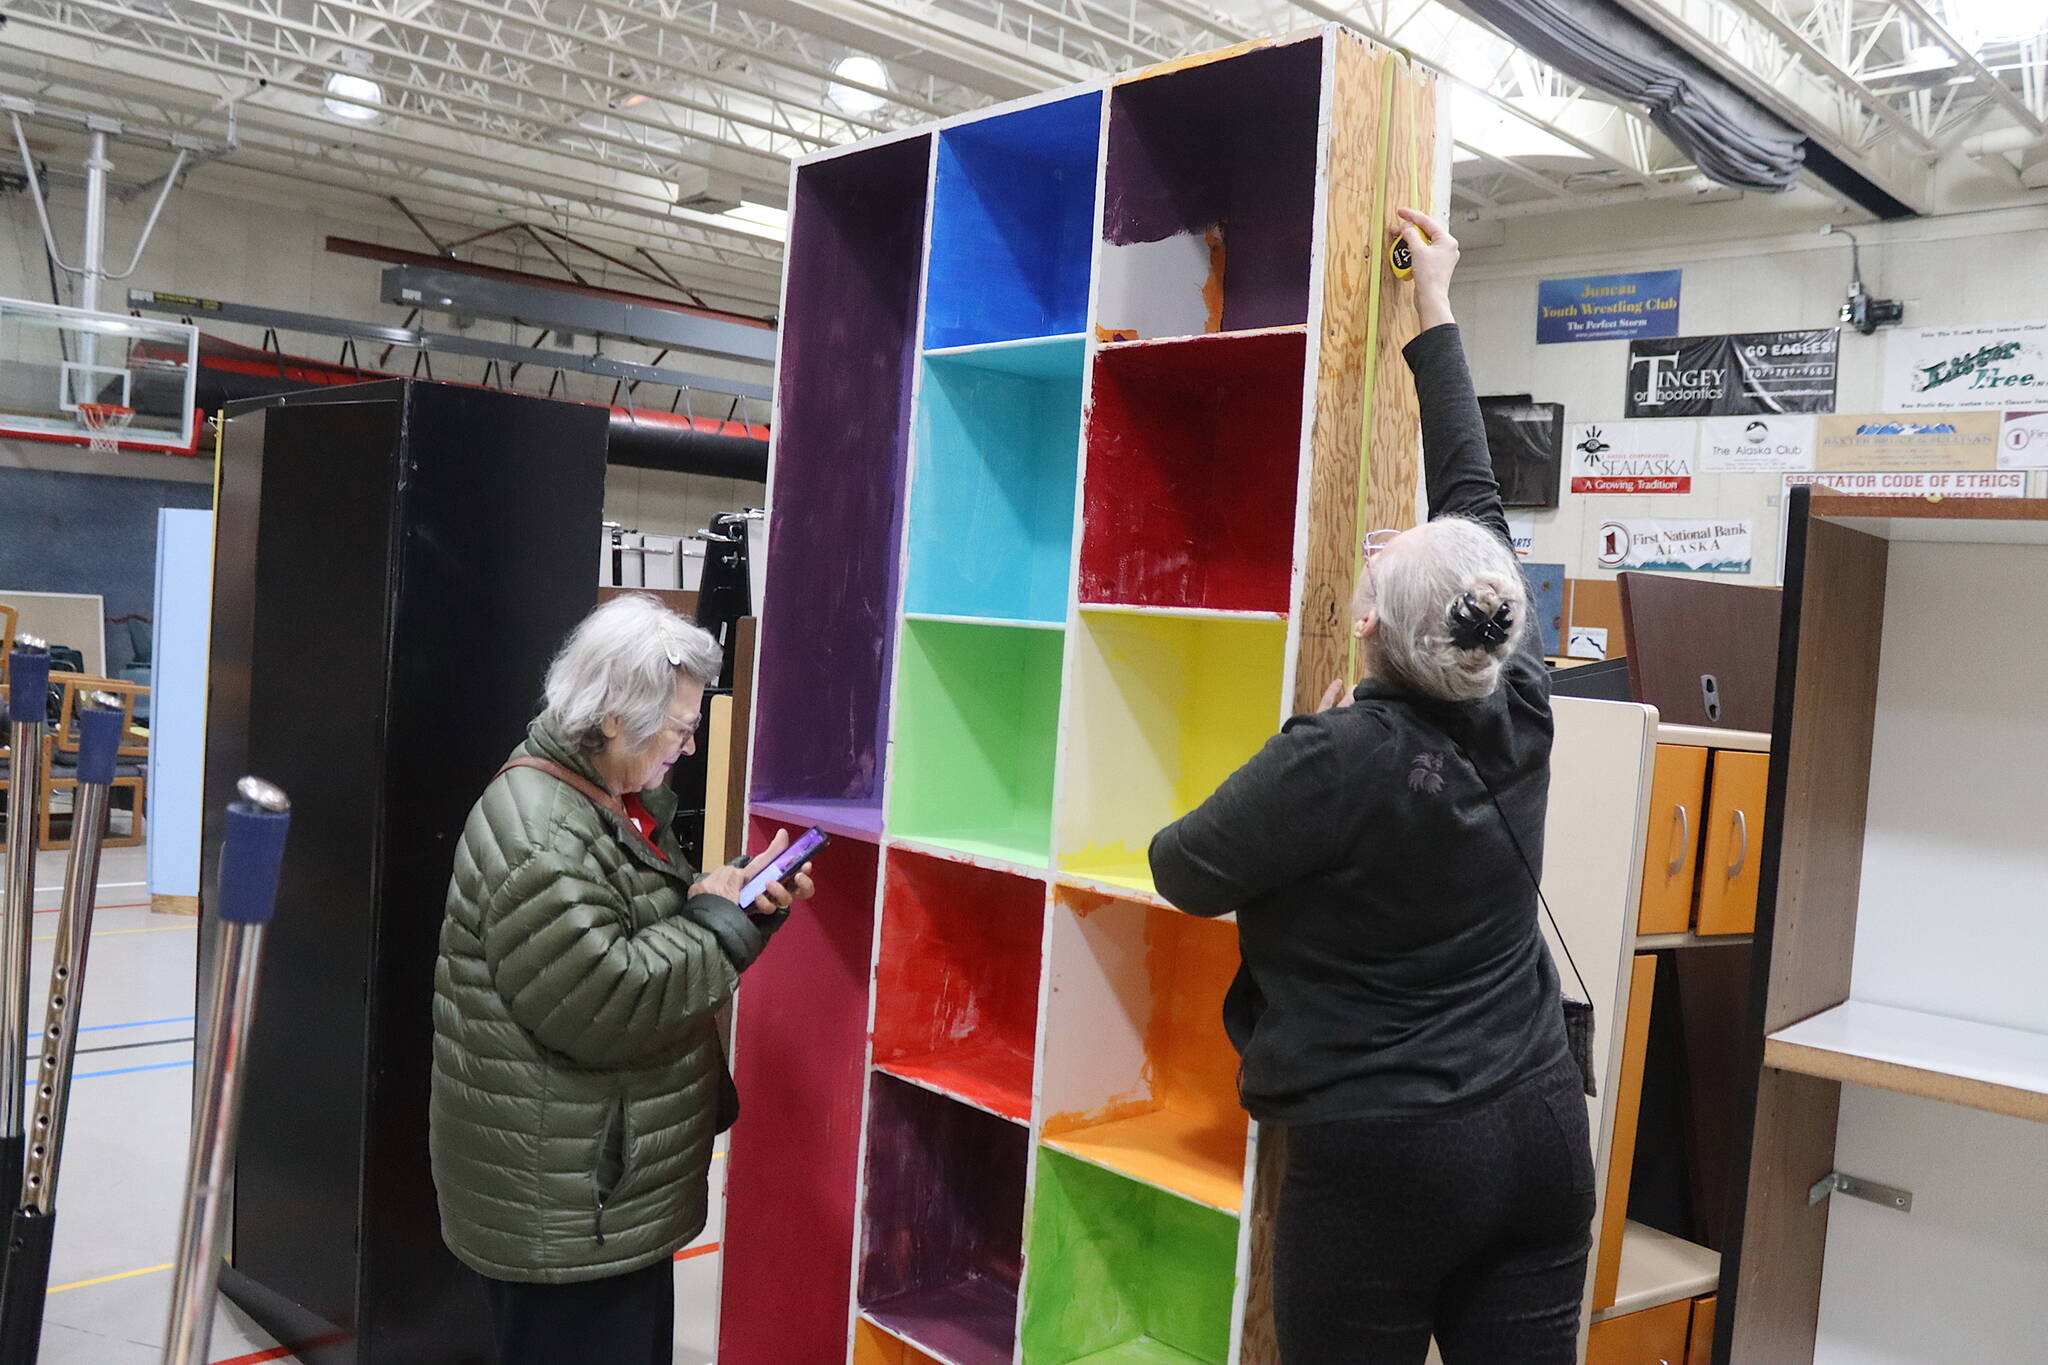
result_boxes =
[1151,209,1593,1365]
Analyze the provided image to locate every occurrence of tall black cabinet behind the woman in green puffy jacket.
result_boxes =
[201,381,606,1365]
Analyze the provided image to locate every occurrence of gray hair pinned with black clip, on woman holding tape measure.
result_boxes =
[1364,516,1530,702]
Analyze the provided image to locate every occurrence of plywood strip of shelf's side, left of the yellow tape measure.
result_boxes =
[1294,33,1384,712]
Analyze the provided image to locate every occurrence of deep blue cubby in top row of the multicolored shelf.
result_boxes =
[924,92,1102,350]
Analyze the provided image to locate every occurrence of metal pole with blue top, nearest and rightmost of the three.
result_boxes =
[164,778,291,1365]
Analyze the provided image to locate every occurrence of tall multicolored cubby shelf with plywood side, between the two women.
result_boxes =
[719,29,1440,1365]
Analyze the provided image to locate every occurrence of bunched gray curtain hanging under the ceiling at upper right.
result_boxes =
[1458,0,1804,192]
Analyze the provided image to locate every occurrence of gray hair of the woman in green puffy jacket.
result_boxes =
[545,593,725,753]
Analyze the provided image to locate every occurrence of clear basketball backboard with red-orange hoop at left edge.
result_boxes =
[0,299,199,452]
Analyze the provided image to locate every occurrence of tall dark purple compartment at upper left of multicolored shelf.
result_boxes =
[752,135,932,833]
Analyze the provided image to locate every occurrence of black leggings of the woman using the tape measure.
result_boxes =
[1274,1060,1593,1365]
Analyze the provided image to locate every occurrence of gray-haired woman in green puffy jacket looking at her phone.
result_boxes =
[430,596,811,1365]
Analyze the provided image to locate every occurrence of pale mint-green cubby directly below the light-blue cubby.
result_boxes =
[889,618,1065,868]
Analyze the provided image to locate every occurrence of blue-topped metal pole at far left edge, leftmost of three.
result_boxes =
[0,634,49,1209]
